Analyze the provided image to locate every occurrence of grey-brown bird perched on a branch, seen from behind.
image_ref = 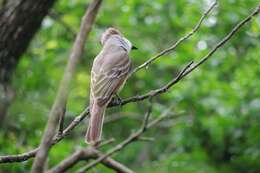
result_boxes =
[85,27,137,145]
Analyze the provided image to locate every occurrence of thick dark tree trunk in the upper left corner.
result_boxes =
[0,0,56,124]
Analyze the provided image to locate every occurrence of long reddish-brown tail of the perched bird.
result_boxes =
[85,103,106,145]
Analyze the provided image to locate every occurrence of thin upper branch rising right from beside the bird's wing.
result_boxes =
[132,0,217,74]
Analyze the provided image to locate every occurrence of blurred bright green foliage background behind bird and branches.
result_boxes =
[0,0,260,173]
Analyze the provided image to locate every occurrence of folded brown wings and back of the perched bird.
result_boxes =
[91,51,131,106]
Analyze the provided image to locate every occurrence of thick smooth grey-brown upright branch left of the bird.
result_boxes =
[32,0,102,173]
